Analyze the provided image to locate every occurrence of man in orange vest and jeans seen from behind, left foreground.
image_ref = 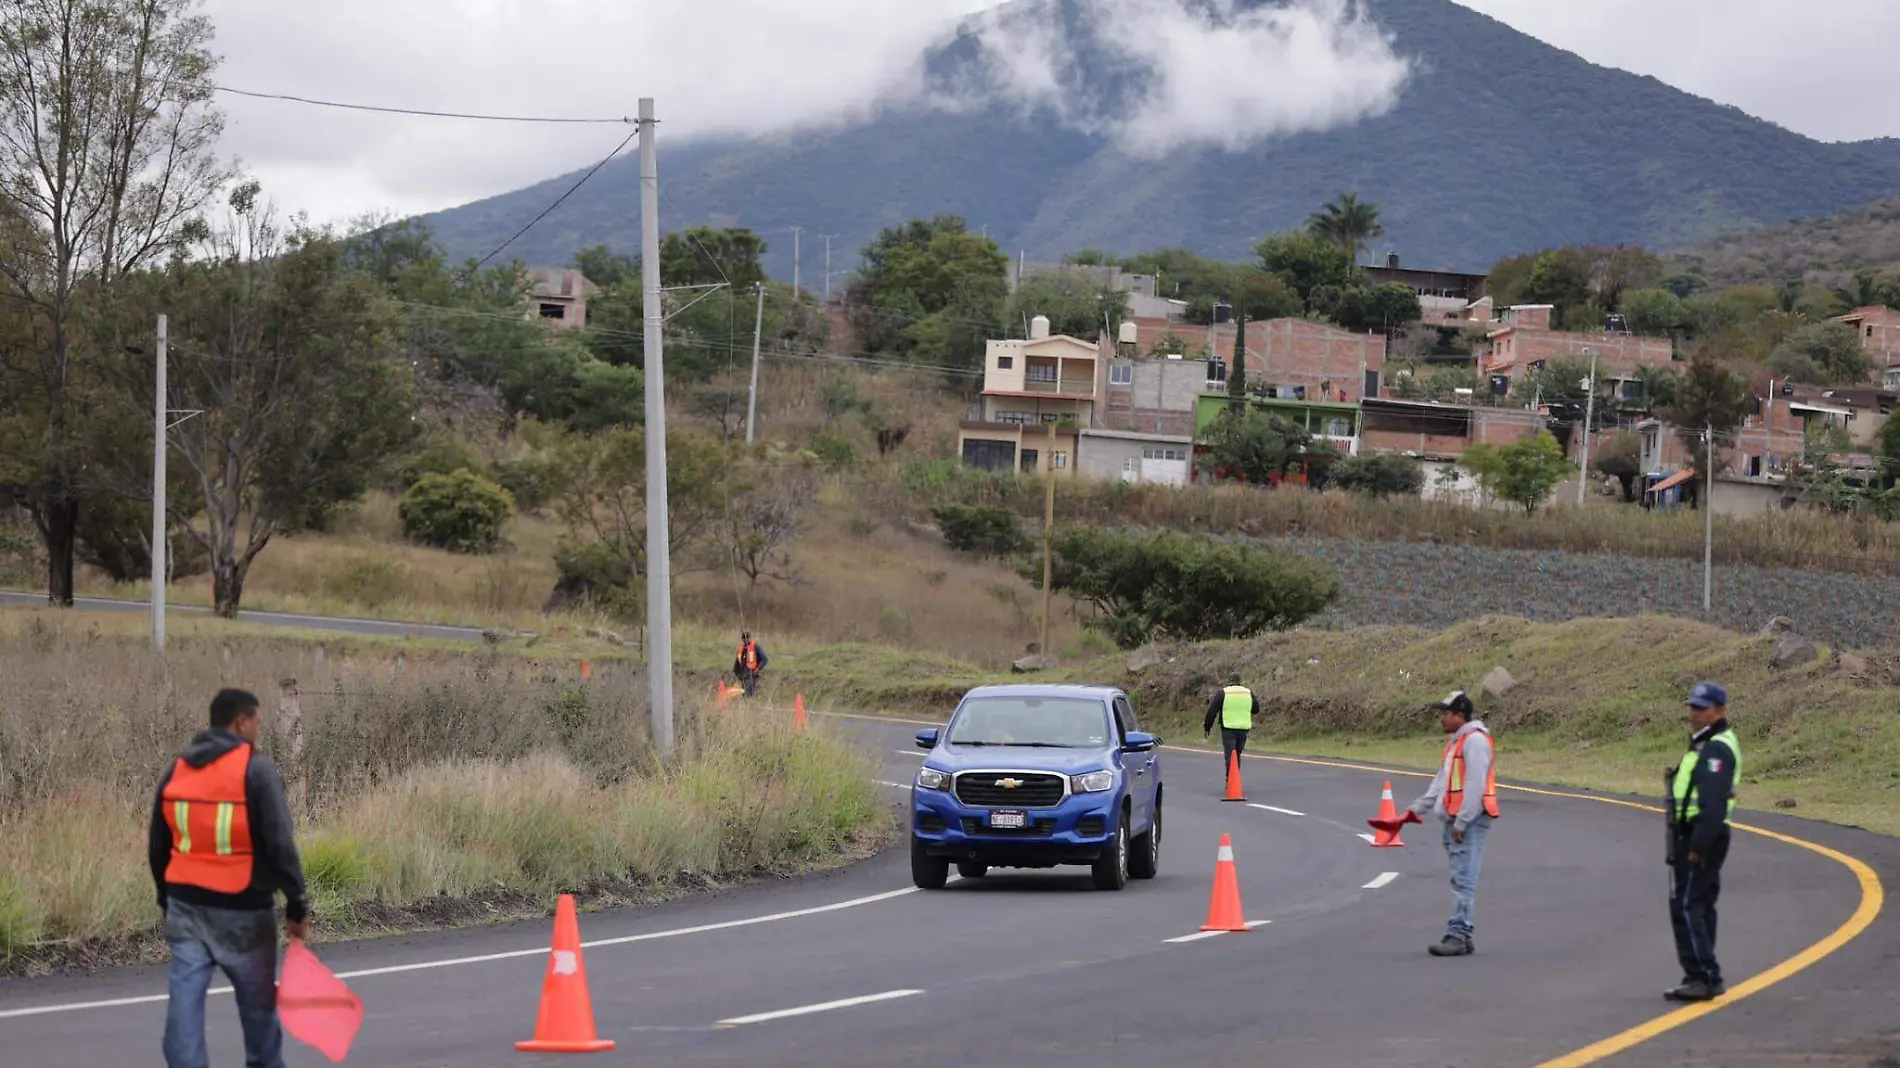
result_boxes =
[148,690,310,1068]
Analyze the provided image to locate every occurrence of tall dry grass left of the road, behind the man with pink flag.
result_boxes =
[0,612,889,971]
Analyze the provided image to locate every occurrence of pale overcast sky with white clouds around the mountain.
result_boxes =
[205,0,1900,228]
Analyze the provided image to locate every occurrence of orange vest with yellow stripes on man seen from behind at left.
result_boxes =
[163,743,251,893]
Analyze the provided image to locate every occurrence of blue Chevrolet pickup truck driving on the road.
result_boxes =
[910,686,1161,889]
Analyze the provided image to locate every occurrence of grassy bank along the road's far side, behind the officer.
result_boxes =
[752,616,1900,834]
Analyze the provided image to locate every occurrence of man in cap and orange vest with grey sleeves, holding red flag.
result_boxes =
[1408,690,1497,956]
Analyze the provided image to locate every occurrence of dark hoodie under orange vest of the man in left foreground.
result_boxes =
[148,728,304,924]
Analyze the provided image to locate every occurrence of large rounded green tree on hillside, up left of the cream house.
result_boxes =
[846,215,1009,367]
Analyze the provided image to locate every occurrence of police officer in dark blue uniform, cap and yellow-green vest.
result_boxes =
[1664,682,1742,1001]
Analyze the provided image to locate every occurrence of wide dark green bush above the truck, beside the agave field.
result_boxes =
[1020,526,1340,648]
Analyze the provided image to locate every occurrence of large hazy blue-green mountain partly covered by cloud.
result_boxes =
[429,0,1900,287]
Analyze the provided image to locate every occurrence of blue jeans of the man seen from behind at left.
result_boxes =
[165,899,283,1068]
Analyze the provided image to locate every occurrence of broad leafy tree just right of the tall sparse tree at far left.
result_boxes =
[122,194,418,618]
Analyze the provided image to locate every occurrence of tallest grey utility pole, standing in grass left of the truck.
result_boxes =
[640,97,673,756]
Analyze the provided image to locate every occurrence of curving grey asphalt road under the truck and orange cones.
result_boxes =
[0,720,1900,1068]
